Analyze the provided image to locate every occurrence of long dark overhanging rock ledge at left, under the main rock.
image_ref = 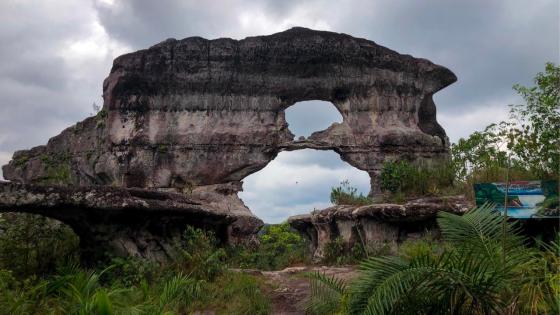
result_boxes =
[0,182,247,262]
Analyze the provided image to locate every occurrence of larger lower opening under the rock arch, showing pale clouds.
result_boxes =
[239,149,370,223]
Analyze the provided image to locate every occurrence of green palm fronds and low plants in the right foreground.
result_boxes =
[307,205,560,314]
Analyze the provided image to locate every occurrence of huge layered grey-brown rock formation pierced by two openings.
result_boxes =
[3,28,456,260]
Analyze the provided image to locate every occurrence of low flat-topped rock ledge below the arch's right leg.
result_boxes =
[288,196,473,259]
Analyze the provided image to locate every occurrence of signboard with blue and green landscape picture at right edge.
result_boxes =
[474,181,560,219]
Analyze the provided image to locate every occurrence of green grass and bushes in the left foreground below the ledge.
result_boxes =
[0,215,270,315]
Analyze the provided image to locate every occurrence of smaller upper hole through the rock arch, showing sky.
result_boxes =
[285,100,343,140]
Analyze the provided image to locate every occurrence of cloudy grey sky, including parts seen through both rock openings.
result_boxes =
[0,0,560,222]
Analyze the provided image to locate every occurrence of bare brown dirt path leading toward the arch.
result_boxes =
[243,266,356,315]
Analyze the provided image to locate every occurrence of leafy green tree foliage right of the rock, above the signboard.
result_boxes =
[451,63,560,180]
